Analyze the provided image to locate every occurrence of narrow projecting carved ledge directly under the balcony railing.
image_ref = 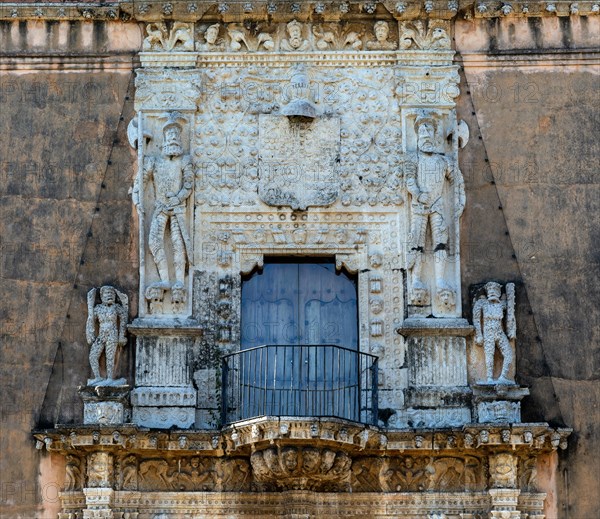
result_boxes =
[34,417,572,456]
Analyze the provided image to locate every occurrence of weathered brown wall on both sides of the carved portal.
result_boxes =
[0,12,600,519]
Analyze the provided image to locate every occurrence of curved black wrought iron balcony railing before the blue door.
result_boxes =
[221,345,377,424]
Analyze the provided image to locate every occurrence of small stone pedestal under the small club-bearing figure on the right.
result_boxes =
[472,384,529,423]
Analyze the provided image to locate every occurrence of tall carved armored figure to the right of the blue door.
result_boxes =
[406,115,465,307]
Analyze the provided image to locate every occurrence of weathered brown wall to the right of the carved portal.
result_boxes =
[455,17,600,518]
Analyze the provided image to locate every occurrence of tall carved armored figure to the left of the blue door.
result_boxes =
[134,112,194,304]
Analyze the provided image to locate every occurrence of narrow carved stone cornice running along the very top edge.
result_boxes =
[0,0,600,22]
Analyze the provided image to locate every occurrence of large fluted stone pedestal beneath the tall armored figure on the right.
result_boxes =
[398,319,473,427]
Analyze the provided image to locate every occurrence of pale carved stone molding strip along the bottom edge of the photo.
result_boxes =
[59,490,546,519]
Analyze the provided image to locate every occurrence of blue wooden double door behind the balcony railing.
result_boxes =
[240,261,358,419]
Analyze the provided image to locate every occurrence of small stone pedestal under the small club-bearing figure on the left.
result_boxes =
[79,385,131,425]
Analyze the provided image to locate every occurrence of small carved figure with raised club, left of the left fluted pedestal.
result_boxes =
[85,286,129,386]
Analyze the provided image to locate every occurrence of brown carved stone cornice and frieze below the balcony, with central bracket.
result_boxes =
[34,418,570,496]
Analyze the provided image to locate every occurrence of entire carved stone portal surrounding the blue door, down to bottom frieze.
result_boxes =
[31,3,569,519]
